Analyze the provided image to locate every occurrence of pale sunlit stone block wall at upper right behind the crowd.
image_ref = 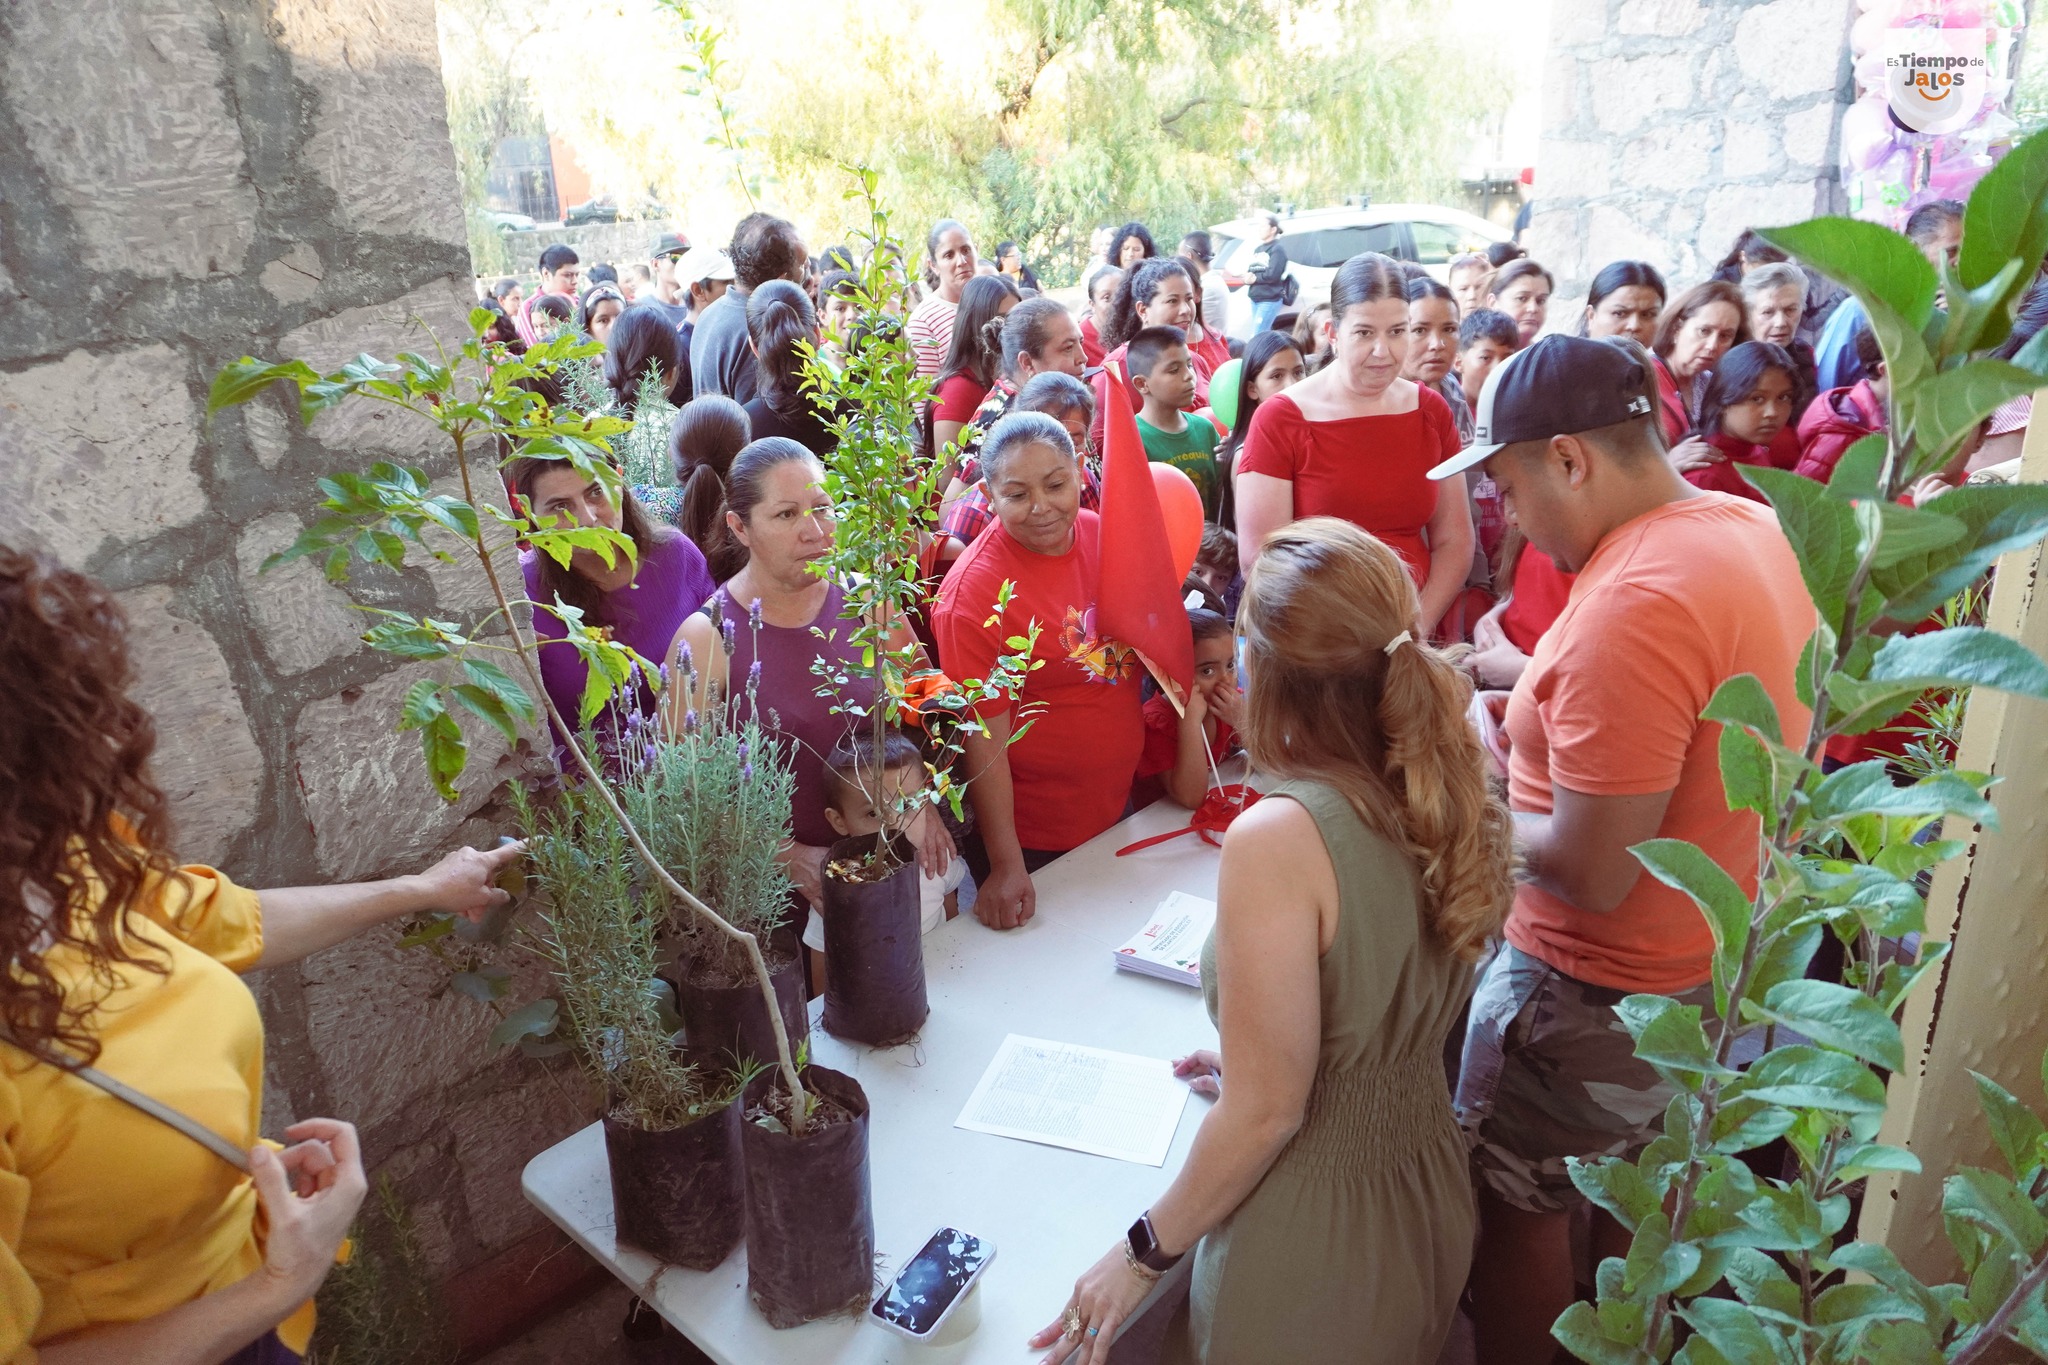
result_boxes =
[1524,0,1853,327]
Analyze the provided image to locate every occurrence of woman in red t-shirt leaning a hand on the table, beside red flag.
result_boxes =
[932,411,1145,929]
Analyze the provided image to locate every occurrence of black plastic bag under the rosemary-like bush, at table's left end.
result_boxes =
[604,1062,745,1271]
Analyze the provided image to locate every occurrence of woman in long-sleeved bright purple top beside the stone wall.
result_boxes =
[506,458,711,772]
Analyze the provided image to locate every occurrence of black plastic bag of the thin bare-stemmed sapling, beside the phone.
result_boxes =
[739,1066,874,1328]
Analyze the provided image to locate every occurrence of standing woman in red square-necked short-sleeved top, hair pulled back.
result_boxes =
[1237,252,1473,634]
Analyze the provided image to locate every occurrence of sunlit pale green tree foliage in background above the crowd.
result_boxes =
[442,0,1507,282]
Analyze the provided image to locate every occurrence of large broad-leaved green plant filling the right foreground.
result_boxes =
[1554,137,2048,1365]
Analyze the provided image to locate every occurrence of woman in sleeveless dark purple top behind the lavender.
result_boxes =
[668,436,952,909]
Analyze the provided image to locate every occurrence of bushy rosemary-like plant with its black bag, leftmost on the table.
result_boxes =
[512,786,748,1271]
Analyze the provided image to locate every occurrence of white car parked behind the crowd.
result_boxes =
[1208,205,1513,340]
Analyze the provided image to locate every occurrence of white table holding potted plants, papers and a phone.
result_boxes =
[522,800,1219,1365]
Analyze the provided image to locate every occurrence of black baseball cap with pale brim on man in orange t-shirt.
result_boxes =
[1430,336,1651,479]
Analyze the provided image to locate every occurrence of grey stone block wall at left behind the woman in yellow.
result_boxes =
[0,0,588,1342]
